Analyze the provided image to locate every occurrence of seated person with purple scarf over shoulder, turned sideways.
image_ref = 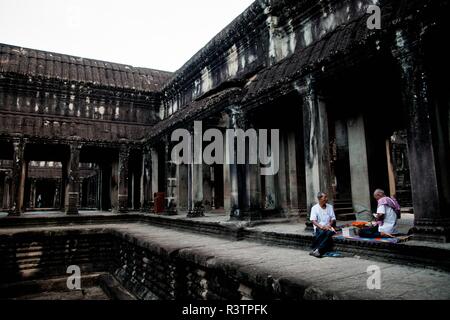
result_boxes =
[359,189,400,238]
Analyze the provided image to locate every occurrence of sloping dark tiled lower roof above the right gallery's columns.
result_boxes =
[243,0,436,103]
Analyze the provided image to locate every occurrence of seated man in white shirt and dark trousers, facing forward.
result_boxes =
[310,192,336,258]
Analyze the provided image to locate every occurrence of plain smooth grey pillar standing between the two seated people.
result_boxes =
[347,115,371,220]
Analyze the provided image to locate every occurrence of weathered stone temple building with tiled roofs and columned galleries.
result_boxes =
[0,0,450,242]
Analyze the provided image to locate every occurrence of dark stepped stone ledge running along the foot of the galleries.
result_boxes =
[0,213,450,271]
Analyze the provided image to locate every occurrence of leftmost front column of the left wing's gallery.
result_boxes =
[9,139,27,216]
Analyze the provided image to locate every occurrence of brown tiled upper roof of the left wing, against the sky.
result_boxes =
[0,43,172,91]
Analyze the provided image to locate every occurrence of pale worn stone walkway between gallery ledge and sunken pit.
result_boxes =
[0,223,450,300]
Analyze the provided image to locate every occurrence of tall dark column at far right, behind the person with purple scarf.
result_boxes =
[393,30,450,242]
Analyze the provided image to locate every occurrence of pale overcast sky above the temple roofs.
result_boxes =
[0,0,253,71]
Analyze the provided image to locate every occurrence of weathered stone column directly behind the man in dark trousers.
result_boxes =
[302,78,333,217]
